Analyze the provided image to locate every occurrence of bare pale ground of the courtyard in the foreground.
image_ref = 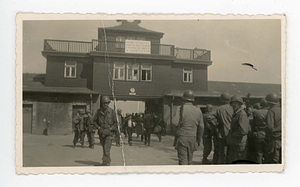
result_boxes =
[23,134,212,167]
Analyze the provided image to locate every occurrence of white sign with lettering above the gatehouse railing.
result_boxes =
[125,40,151,54]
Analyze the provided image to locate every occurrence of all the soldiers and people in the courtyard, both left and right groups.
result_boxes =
[73,90,282,166]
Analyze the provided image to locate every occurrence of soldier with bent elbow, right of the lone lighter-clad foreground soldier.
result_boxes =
[207,93,233,164]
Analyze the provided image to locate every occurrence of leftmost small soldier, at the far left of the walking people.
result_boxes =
[73,109,85,147]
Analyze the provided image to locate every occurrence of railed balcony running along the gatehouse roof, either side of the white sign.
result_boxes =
[44,39,210,60]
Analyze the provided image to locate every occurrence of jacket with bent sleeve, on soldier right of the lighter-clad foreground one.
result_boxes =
[207,104,233,139]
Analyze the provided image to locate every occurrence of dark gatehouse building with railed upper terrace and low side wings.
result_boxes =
[23,20,280,134]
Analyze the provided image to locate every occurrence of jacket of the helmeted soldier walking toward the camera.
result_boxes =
[94,107,118,131]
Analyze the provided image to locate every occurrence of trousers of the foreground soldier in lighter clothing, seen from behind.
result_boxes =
[176,136,196,165]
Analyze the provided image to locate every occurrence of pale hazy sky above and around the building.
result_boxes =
[23,19,281,84]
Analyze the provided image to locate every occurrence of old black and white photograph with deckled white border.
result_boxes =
[16,14,286,173]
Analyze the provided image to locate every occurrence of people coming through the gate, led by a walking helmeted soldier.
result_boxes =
[73,96,166,166]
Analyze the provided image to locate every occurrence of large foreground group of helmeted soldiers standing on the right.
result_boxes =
[173,90,282,165]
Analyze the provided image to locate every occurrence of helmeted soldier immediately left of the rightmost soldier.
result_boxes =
[252,99,269,164]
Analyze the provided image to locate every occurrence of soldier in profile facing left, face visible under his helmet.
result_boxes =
[227,96,250,163]
